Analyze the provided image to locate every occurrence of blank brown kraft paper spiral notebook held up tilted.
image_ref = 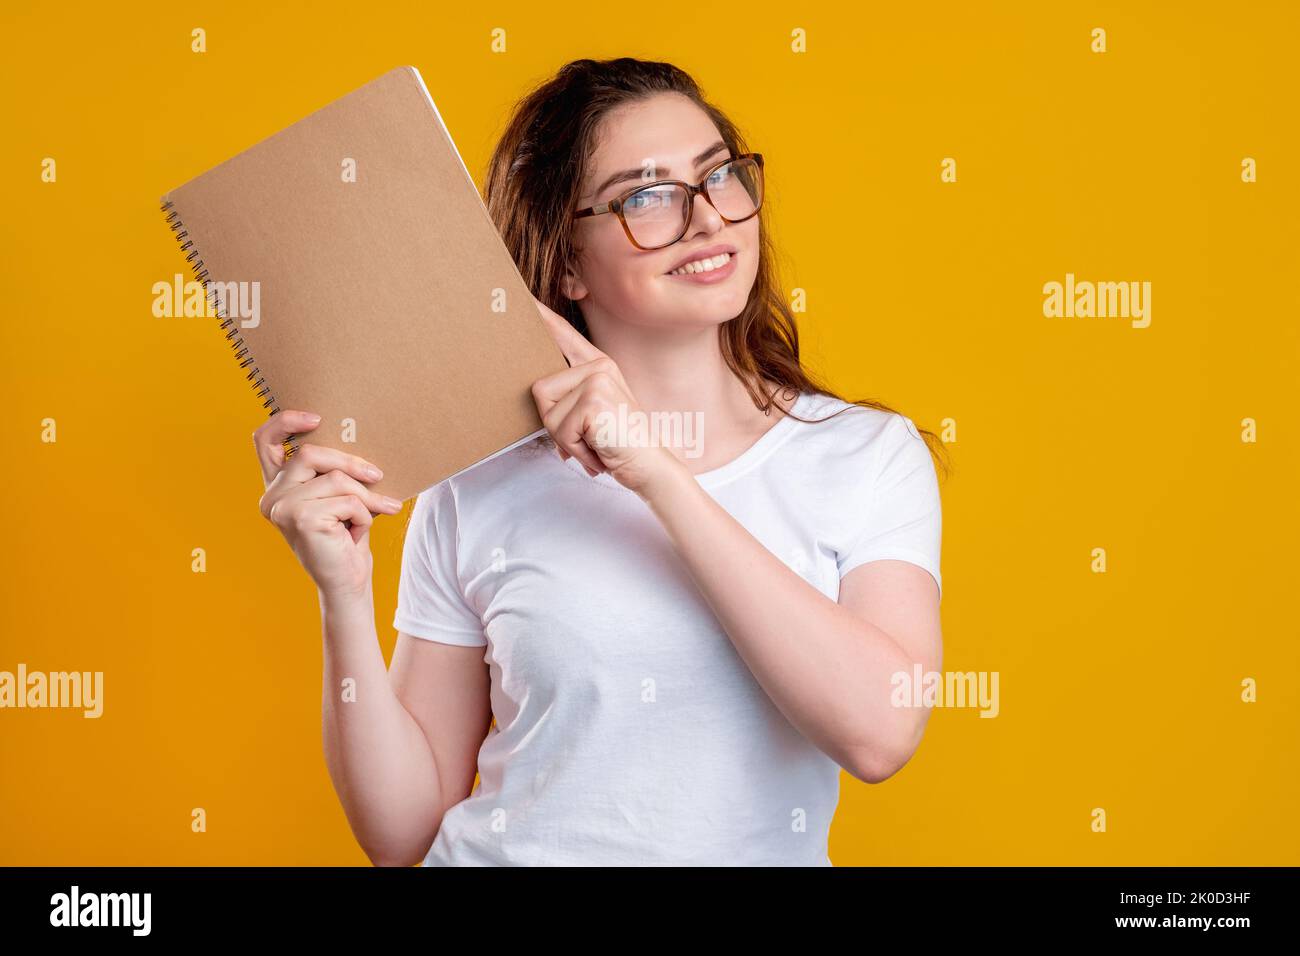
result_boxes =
[163,66,568,501]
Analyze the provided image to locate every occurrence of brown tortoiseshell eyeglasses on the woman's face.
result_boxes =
[573,152,763,250]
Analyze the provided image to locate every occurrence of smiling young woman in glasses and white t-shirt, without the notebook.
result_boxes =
[255,59,941,866]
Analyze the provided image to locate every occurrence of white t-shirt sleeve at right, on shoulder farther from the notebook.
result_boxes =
[839,412,944,597]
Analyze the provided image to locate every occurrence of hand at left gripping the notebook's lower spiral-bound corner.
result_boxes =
[252,410,402,596]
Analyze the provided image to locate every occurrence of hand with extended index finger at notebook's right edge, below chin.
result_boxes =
[533,295,685,494]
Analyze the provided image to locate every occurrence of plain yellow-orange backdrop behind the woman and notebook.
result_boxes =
[0,3,1300,865]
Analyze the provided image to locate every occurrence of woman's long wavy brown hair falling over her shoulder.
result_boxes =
[485,57,949,476]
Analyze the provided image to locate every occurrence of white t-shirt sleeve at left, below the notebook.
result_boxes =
[393,481,488,646]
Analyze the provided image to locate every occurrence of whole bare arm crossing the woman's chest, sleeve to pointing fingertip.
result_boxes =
[533,300,941,783]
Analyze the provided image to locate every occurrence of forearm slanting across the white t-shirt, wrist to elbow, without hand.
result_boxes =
[641,467,928,778]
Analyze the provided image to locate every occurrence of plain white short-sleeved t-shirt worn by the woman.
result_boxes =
[393,393,941,866]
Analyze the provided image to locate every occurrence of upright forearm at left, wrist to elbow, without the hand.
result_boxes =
[320,589,445,865]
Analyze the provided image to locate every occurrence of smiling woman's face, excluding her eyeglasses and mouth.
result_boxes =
[566,94,759,328]
